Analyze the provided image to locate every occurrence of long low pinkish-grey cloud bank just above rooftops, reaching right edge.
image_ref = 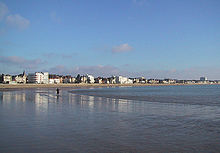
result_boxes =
[45,65,220,80]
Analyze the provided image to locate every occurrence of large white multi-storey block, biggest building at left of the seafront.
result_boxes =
[28,72,49,84]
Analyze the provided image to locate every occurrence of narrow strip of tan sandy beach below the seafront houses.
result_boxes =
[0,83,220,90]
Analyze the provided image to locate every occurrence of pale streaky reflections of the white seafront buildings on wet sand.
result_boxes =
[1,90,133,112]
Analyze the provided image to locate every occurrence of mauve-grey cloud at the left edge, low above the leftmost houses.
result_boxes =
[0,56,45,69]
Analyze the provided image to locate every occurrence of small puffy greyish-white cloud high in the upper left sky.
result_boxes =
[6,14,30,29]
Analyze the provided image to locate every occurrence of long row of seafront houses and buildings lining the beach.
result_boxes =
[0,72,220,84]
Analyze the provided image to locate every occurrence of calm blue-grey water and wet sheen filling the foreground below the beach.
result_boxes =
[0,85,220,153]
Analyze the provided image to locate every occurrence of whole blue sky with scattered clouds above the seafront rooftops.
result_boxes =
[0,0,220,80]
